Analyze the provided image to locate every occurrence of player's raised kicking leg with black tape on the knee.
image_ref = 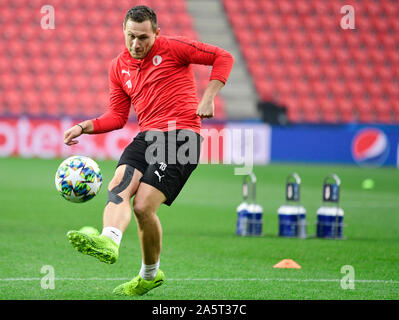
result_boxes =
[67,165,142,263]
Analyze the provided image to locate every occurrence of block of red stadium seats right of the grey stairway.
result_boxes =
[223,0,399,123]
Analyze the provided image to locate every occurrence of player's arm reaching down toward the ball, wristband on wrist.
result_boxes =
[64,59,131,146]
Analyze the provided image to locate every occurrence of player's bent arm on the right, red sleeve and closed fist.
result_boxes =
[170,37,234,118]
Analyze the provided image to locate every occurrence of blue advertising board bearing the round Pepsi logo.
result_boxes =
[270,124,399,167]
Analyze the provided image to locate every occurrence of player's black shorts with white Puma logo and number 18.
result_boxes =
[118,129,203,206]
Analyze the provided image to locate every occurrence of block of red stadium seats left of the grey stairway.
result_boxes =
[0,0,225,120]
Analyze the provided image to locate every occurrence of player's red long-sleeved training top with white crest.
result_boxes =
[92,36,234,133]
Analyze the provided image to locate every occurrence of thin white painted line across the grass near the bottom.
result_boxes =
[0,278,399,284]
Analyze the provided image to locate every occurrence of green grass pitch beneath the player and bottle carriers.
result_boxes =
[0,158,399,300]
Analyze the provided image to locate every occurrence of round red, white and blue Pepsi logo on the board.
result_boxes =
[352,128,389,167]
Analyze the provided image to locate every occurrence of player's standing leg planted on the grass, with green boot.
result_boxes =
[114,182,166,296]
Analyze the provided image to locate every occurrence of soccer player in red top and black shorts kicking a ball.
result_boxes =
[64,6,233,296]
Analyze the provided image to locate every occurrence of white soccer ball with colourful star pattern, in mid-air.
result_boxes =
[55,156,103,202]
